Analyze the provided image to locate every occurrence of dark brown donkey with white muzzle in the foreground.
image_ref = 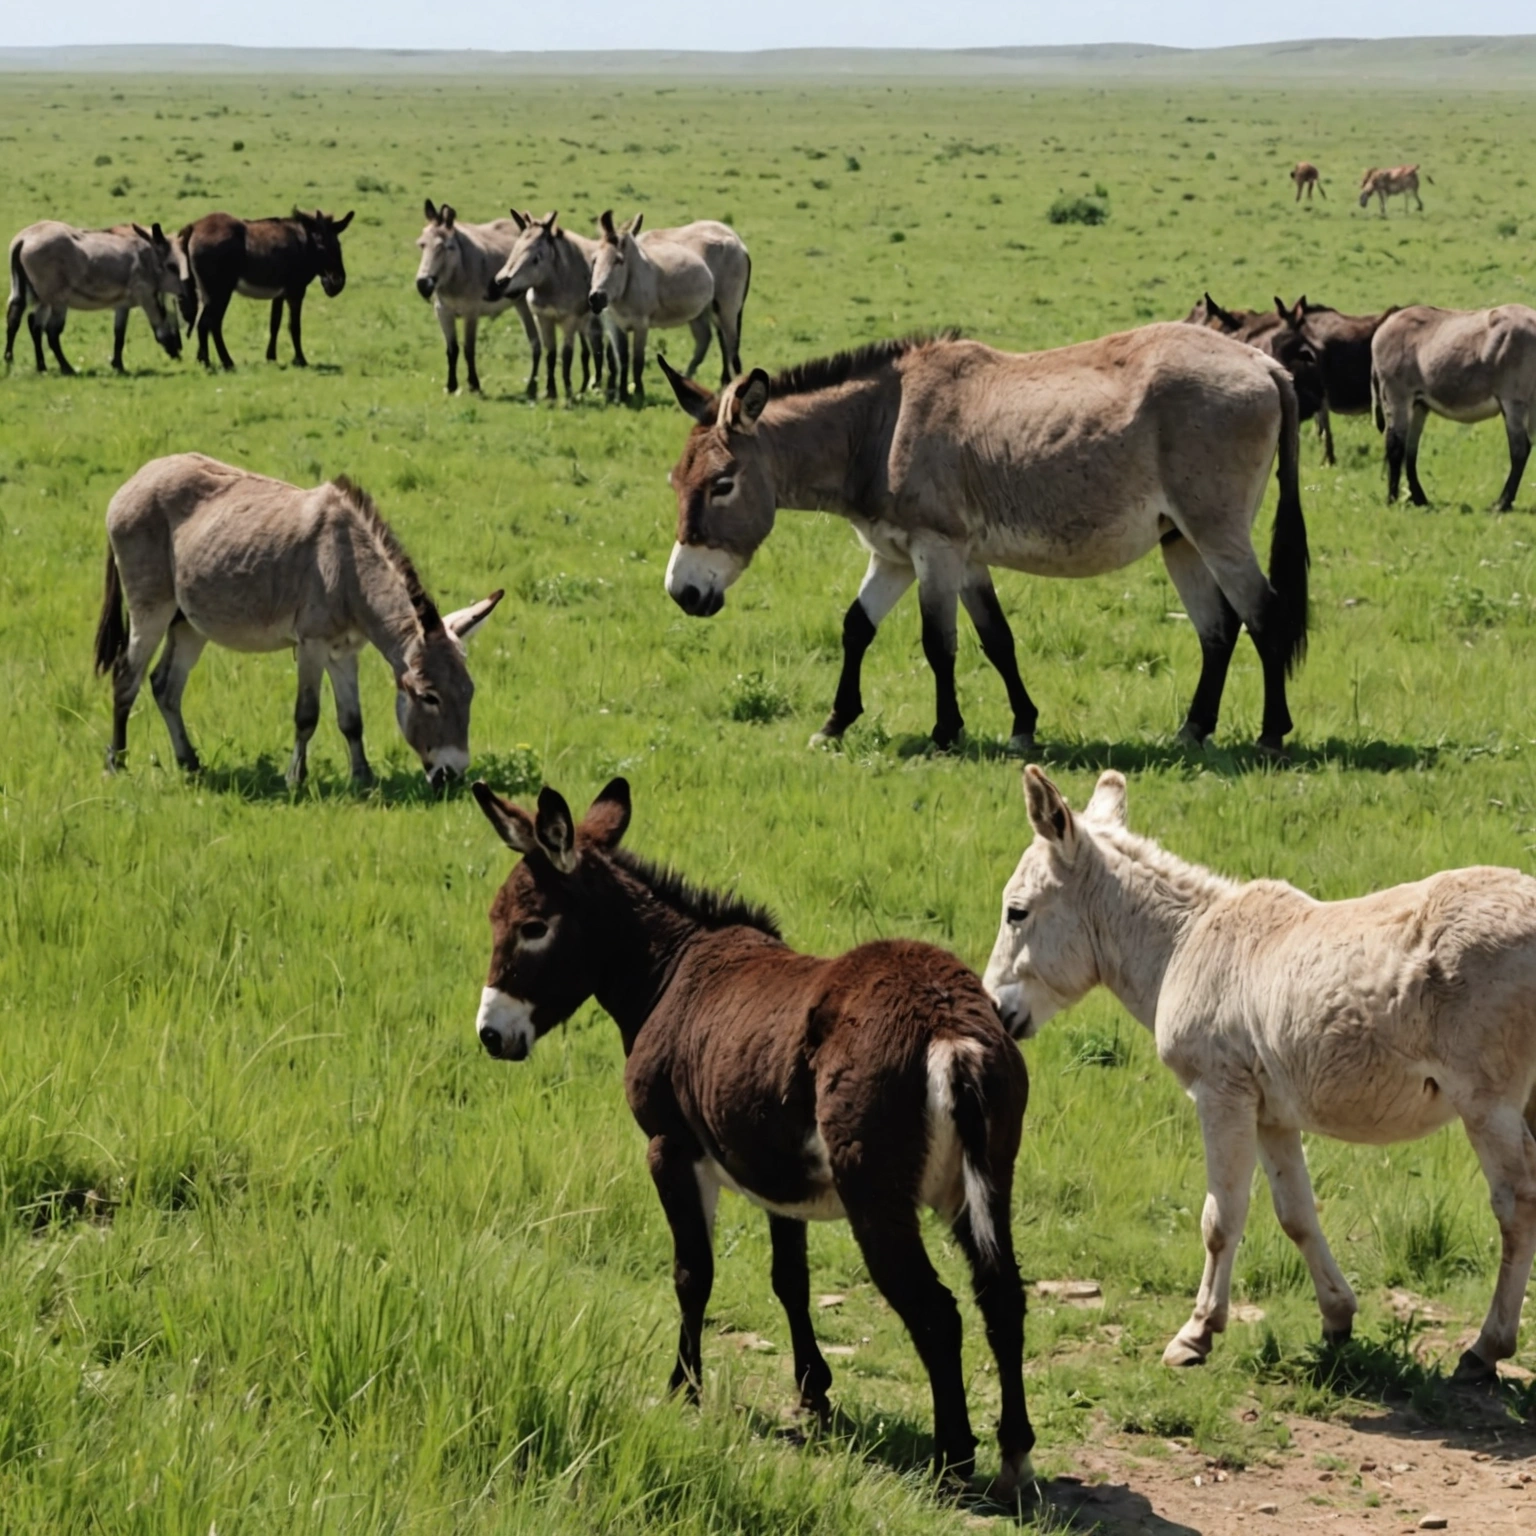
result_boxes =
[475,779,1035,1499]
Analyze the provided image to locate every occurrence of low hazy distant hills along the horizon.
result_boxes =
[0,35,1536,88]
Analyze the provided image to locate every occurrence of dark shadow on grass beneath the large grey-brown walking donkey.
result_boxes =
[891,736,1442,779]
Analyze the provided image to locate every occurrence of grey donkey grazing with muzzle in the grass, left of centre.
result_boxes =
[95,453,502,788]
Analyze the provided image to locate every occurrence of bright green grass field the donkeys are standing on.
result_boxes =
[0,77,1536,1536]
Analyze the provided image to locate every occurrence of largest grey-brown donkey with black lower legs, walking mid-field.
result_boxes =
[662,324,1307,754]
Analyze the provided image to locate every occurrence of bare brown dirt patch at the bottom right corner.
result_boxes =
[1041,1393,1536,1536]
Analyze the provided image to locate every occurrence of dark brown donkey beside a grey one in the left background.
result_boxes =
[177,209,352,369]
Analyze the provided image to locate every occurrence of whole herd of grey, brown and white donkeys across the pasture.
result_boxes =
[6,152,1536,1501]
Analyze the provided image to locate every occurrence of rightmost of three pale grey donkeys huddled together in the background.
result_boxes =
[590,212,753,399]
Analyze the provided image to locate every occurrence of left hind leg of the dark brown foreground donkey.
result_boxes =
[840,1210,975,1481]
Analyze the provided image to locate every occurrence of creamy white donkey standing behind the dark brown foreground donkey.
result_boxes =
[986,766,1536,1379]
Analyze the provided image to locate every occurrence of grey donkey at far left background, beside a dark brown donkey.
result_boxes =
[5,220,183,375]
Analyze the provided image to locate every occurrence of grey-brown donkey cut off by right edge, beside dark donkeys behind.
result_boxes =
[1370,304,1536,511]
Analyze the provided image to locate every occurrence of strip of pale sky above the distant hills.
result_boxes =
[12,0,1536,49]
